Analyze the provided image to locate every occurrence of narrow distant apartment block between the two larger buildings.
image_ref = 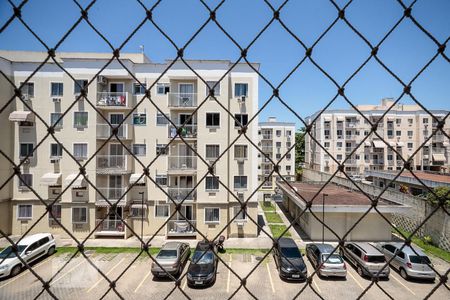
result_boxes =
[258,117,295,200]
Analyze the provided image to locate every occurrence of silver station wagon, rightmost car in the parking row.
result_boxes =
[378,242,436,280]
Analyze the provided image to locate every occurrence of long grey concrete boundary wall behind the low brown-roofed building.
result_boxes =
[303,169,450,251]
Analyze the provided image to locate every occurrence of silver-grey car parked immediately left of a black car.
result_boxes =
[152,242,191,277]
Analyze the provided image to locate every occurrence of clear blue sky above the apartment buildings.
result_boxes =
[0,0,450,125]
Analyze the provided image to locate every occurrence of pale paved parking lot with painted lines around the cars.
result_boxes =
[0,253,450,299]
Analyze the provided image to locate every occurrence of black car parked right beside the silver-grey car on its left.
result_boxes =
[187,241,218,287]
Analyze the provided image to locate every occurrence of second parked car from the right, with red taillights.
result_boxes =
[340,242,389,278]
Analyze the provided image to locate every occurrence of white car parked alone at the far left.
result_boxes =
[0,233,56,278]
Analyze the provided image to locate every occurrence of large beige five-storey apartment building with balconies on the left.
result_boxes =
[0,51,259,238]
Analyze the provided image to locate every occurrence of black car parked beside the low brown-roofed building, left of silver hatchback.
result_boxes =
[273,237,308,280]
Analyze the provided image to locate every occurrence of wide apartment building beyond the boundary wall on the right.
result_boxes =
[305,99,450,175]
